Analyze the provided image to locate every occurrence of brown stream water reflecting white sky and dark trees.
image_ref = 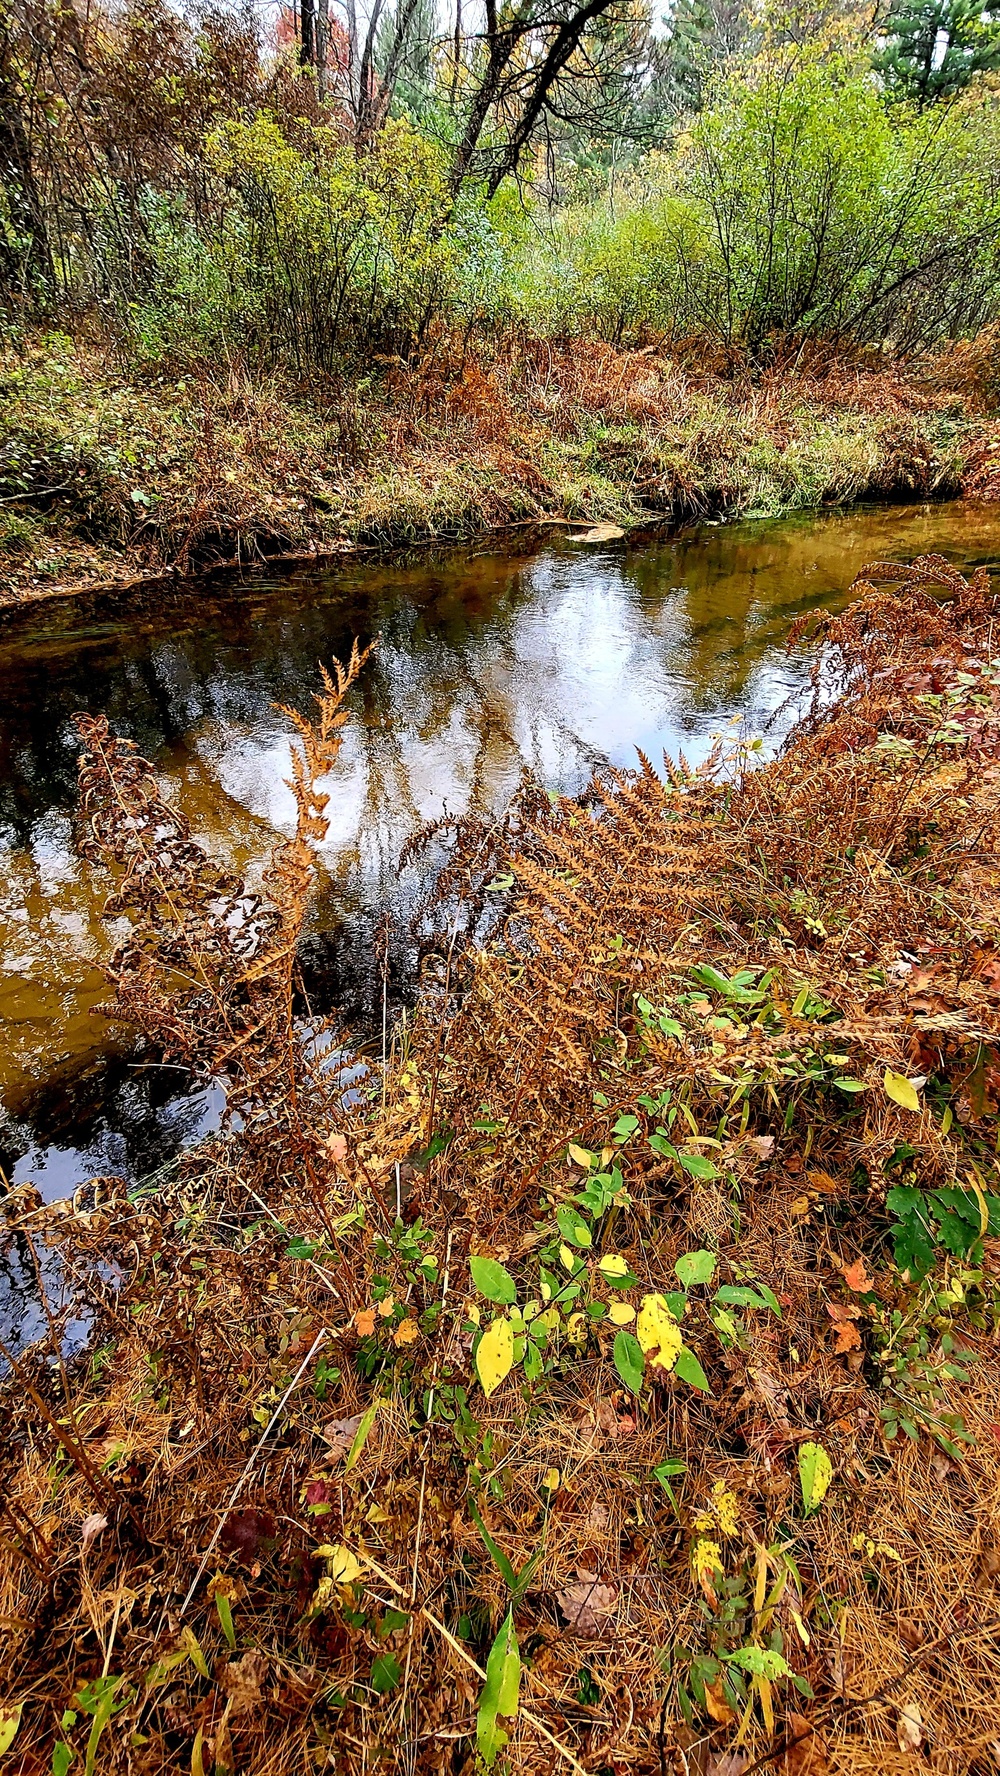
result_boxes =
[0,504,1000,1221]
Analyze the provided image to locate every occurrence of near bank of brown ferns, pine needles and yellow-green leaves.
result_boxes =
[0,558,1000,1776]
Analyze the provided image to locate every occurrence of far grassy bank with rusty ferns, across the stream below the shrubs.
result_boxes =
[0,334,995,602]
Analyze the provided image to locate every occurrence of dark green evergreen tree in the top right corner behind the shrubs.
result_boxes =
[874,0,1000,107]
